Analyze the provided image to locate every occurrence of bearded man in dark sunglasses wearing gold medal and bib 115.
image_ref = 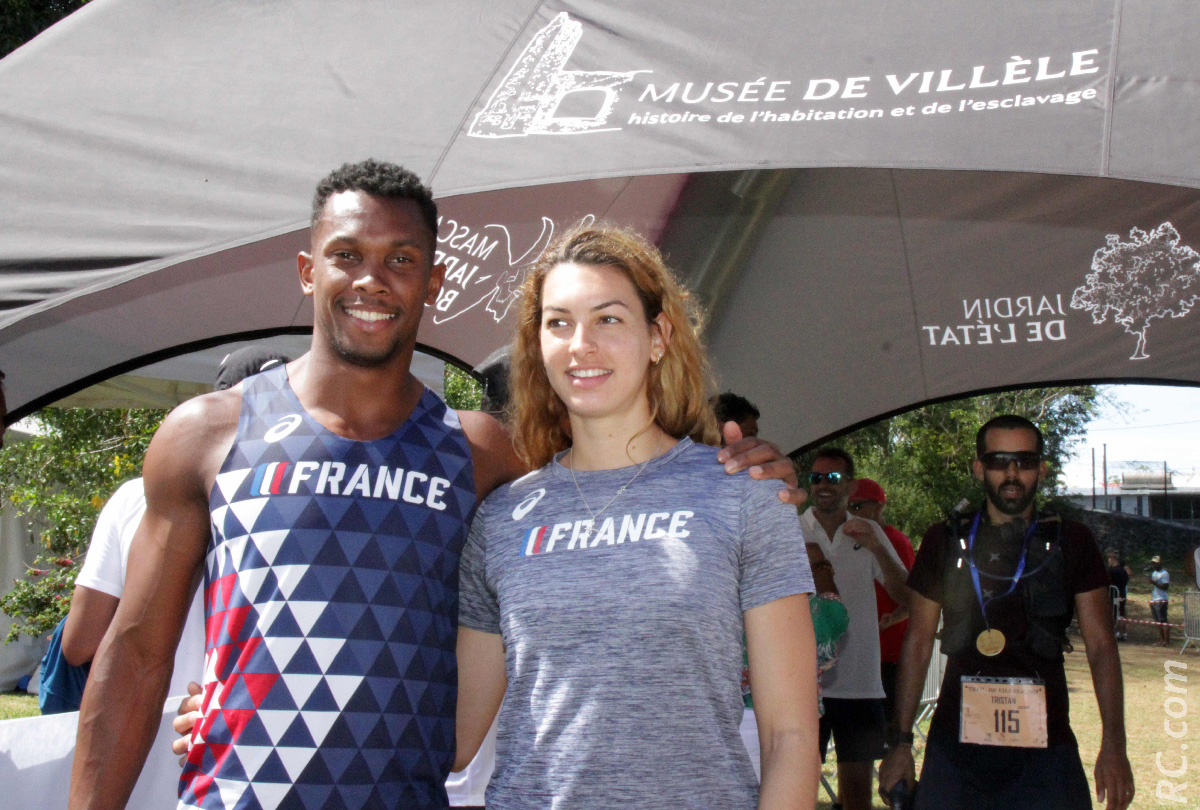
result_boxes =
[880,415,1134,810]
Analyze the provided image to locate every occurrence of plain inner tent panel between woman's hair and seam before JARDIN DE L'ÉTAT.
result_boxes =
[709,169,929,450]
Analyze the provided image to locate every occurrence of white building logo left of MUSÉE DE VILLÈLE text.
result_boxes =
[467,11,650,138]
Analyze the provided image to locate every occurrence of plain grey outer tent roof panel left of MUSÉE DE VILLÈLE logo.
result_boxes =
[0,0,535,260]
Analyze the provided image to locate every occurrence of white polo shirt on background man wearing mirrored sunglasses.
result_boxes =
[800,506,901,698]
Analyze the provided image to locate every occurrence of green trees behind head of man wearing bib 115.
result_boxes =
[802,385,1103,542]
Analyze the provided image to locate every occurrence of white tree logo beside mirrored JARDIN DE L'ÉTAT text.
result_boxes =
[1070,222,1200,360]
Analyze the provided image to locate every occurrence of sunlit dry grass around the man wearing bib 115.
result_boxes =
[817,568,1200,810]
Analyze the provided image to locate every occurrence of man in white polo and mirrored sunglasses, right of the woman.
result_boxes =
[800,448,910,810]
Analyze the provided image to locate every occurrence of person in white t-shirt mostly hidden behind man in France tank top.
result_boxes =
[62,346,290,708]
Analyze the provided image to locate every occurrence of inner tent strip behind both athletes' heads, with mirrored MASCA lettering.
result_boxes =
[0,175,685,412]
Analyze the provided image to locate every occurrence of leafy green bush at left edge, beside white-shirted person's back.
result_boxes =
[0,408,167,642]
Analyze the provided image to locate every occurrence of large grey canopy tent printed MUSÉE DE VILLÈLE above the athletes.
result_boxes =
[0,0,1200,449]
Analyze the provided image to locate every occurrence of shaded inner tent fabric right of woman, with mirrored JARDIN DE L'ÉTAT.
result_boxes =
[712,169,1200,448]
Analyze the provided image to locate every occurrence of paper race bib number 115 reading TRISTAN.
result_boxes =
[959,676,1048,748]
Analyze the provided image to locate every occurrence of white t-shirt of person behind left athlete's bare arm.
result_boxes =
[76,478,204,696]
